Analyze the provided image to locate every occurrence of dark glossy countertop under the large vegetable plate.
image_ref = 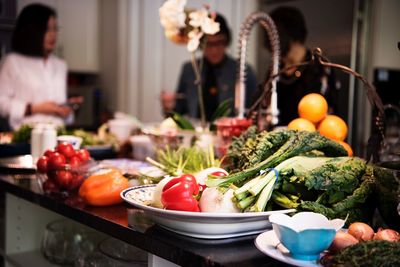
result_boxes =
[0,169,285,266]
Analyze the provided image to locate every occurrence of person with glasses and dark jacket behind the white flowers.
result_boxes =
[161,14,257,121]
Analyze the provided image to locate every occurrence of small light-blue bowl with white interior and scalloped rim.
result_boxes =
[269,212,345,260]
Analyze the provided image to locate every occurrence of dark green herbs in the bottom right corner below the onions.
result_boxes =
[321,240,400,267]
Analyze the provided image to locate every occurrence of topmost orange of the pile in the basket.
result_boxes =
[297,93,328,123]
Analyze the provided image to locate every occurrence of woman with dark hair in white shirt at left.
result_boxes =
[0,4,80,129]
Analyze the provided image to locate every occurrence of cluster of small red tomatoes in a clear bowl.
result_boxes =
[36,143,90,192]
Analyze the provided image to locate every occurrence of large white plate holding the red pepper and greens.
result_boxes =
[121,185,295,239]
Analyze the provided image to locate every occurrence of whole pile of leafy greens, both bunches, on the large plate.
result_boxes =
[206,128,375,223]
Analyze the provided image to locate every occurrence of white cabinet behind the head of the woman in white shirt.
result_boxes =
[18,0,99,72]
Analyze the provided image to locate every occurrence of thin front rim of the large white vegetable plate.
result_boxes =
[120,184,296,220]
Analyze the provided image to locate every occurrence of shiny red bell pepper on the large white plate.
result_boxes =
[161,174,200,214]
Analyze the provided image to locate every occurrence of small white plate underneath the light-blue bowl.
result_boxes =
[254,230,322,267]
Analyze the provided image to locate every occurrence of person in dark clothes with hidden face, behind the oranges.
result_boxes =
[270,6,338,125]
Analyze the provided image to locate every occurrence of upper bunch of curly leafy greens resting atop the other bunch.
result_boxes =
[207,128,347,187]
